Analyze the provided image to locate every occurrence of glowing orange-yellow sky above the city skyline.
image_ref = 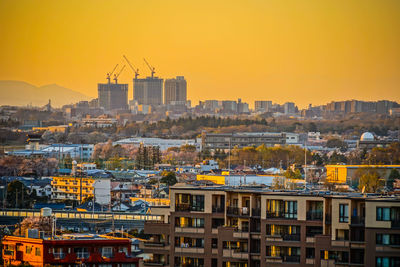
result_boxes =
[0,0,400,107]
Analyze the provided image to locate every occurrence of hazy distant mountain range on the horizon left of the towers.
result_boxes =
[0,81,91,107]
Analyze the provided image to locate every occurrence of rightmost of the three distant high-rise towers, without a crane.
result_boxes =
[164,76,187,105]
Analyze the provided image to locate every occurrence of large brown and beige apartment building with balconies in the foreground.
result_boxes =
[141,186,400,267]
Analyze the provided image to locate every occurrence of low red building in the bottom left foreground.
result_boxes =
[2,235,140,267]
